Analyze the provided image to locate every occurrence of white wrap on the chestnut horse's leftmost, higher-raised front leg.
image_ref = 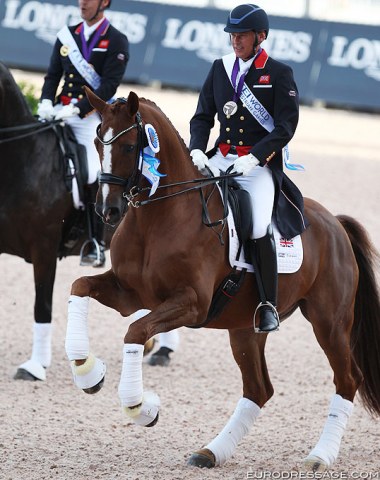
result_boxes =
[65,295,90,360]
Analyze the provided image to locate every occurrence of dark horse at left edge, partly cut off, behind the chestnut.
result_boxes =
[0,63,113,380]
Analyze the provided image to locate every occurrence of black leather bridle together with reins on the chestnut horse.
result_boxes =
[96,107,241,214]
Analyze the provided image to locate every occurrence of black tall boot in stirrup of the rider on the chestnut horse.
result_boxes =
[250,226,280,333]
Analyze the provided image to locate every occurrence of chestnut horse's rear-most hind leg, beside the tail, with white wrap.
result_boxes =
[301,300,362,471]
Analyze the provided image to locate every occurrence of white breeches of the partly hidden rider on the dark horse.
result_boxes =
[58,108,100,185]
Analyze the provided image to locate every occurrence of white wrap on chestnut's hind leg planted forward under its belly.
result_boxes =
[206,397,260,465]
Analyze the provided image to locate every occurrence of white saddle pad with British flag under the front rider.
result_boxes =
[227,209,303,273]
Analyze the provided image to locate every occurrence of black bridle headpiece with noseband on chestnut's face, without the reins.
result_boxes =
[96,110,144,192]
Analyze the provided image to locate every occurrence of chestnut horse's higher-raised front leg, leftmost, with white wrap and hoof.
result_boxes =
[65,270,138,393]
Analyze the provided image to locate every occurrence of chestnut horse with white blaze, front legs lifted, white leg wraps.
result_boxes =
[66,91,380,471]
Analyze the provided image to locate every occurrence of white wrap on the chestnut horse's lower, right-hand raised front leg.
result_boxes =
[118,343,144,407]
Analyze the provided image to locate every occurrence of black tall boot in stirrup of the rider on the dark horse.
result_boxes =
[80,182,106,267]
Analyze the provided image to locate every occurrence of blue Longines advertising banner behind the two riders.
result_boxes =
[0,0,380,110]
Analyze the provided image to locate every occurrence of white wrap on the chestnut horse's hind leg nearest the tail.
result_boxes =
[308,395,354,467]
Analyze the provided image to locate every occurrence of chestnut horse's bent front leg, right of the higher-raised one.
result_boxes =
[119,288,199,427]
